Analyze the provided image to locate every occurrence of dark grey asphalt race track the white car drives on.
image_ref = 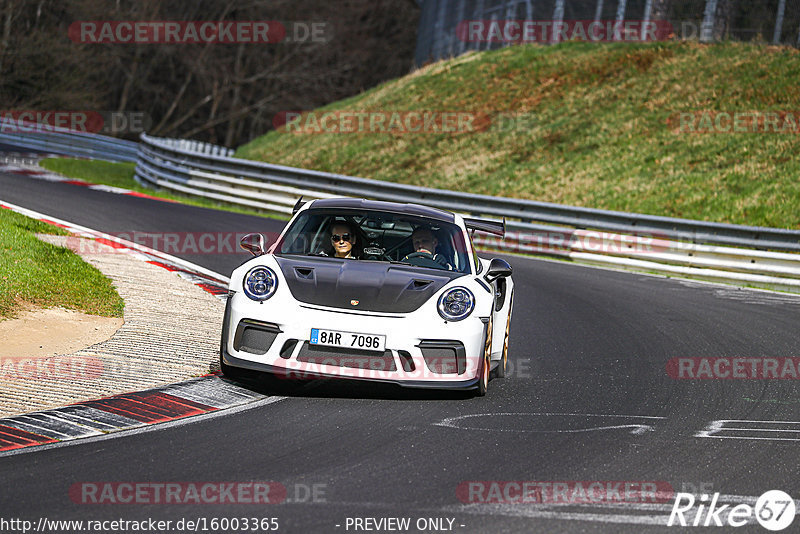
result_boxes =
[0,170,800,533]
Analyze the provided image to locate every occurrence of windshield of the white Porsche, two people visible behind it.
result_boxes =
[274,208,470,273]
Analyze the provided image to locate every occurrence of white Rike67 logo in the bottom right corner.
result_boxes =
[667,490,796,531]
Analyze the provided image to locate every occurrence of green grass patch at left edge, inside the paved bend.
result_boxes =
[0,209,125,319]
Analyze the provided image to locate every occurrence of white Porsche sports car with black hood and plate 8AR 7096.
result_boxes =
[220,198,514,395]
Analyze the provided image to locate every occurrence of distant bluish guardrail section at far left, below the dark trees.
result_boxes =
[0,118,138,162]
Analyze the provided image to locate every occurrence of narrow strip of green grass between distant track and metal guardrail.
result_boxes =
[39,158,288,219]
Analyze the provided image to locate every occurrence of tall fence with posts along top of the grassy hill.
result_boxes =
[415,0,800,66]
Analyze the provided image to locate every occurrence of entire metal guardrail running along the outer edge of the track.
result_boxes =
[0,125,800,292]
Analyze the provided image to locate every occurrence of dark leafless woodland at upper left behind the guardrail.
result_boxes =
[0,0,422,146]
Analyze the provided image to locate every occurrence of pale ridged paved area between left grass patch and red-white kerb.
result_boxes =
[0,235,225,417]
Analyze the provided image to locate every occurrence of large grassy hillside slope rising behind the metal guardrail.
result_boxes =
[236,42,800,228]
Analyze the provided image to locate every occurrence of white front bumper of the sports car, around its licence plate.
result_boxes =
[220,293,486,389]
